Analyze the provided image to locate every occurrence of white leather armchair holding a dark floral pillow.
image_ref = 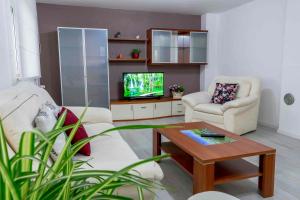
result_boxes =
[182,76,261,135]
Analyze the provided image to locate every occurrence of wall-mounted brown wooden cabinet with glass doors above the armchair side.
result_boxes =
[147,28,208,65]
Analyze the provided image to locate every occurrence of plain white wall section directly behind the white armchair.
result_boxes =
[201,0,285,127]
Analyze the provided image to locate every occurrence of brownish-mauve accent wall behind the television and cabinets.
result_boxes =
[37,4,201,104]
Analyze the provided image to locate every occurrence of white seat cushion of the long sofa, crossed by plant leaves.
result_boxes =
[75,123,163,180]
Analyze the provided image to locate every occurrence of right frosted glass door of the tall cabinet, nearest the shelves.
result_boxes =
[85,29,110,108]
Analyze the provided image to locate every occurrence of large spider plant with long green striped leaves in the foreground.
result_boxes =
[0,109,168,200]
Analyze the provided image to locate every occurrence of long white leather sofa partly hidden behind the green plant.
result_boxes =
[0,83,163,196]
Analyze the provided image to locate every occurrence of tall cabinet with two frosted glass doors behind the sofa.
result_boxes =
[57,27,110,108]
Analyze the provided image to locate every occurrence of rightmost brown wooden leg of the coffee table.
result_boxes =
[258,153,275,198]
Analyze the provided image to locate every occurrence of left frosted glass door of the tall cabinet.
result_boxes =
[58,28,86,106]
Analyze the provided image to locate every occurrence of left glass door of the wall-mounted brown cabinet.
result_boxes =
[152,30,172,63]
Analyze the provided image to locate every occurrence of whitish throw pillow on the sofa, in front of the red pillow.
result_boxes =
[35,104,66,159]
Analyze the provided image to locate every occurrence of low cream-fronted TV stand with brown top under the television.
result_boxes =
[110,97,184,121]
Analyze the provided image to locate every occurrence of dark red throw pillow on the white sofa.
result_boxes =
[58,107,91,156]
